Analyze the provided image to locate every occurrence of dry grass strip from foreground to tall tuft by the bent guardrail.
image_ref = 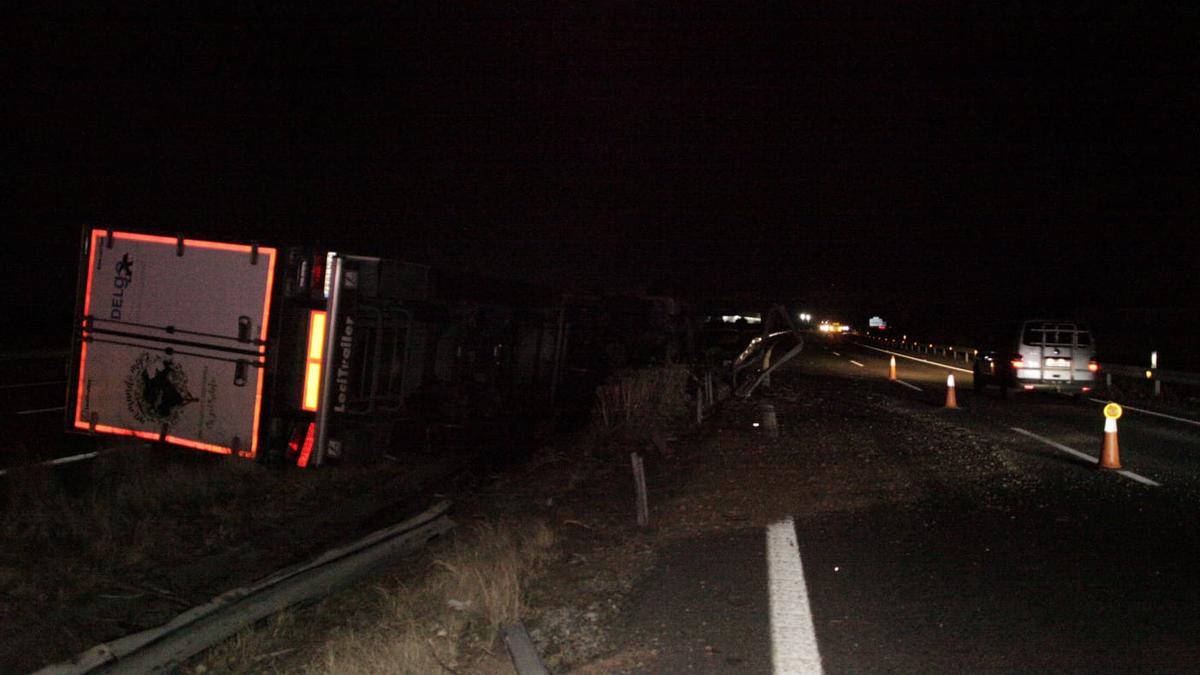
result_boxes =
[188,365,690,674]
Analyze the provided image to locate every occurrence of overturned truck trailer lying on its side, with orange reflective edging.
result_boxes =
[66,228,564,467]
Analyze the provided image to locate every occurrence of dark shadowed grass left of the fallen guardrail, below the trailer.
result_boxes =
[0,447,398,670]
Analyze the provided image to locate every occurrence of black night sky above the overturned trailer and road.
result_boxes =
[11,2,1200,345]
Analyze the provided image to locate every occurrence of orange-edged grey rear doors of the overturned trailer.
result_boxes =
[68,229,276,456]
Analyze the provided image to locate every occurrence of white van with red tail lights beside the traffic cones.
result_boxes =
[974,319,1099,396]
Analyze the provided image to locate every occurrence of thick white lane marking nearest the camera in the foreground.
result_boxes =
[767,516,824,674]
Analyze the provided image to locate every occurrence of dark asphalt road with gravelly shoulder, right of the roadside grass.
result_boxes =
[624,344,1200,673]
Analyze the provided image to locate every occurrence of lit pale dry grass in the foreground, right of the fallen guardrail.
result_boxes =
[190,514,557,675]
